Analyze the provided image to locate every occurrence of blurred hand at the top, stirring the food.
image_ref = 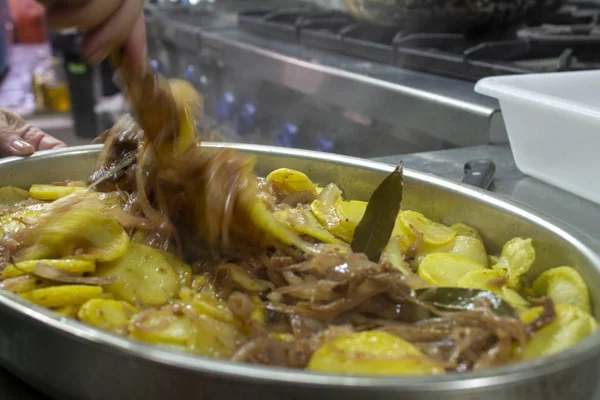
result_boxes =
[38,0,147,71]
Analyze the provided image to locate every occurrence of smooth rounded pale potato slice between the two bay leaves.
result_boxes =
[419,253,484,287]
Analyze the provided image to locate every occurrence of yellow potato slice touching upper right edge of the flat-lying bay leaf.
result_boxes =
[457,269,529,309]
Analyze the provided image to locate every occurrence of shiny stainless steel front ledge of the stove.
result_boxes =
[202,29,505,146]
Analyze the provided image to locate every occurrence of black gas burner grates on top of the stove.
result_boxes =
[239,1,600,81]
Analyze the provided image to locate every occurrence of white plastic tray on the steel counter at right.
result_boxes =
[475,71,600,204]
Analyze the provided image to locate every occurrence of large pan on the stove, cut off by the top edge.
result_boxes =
[344,0,565,33]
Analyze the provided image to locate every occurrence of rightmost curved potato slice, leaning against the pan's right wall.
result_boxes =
[533,267,592,313]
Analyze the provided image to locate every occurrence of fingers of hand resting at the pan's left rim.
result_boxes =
[0,109,67,157]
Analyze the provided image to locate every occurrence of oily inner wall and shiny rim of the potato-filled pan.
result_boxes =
[0,143,600,392]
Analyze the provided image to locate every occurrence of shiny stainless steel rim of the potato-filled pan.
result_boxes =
[0,143,600,393]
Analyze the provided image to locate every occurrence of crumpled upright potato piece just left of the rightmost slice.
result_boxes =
[494,238,535,289]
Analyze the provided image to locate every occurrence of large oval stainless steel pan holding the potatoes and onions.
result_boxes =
[0,144,600,400]
